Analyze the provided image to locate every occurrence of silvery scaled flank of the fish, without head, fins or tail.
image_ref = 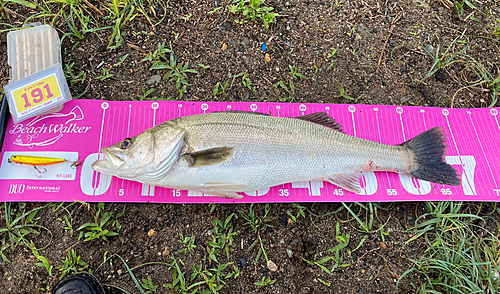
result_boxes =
[150,113,408,191]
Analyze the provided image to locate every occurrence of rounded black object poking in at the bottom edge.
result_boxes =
[54,273,105,294]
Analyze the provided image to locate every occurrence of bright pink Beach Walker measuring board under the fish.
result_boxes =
[0,100,500,203]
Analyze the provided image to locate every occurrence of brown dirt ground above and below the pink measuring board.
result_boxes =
[0,0,500,294]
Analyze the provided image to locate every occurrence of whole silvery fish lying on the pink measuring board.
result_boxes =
[92,111,460,199]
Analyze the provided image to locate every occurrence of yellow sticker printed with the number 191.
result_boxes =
[12,74,63,116]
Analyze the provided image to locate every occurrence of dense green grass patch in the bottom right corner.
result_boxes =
[398,202,500,293]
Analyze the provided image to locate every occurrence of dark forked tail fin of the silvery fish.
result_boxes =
[401,127,460,186]
